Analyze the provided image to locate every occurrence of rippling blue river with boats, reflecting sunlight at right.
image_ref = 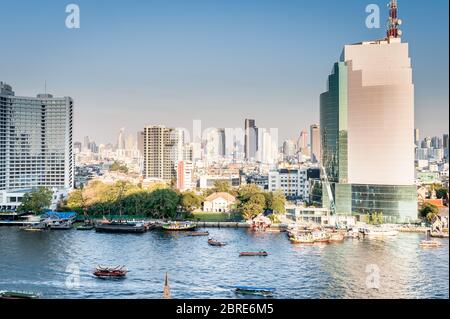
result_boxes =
[0,227,449,299]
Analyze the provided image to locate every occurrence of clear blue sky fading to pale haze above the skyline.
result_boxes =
[0,0,449,143]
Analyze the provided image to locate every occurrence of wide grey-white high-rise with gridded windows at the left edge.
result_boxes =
[0,82,74,210]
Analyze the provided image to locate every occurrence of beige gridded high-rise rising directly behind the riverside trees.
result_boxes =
[143,125,178,183]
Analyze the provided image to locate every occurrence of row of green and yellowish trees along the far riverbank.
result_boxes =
[59,181,286,219]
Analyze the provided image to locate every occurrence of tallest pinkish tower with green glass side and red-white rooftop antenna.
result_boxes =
[320,1,417,222]
